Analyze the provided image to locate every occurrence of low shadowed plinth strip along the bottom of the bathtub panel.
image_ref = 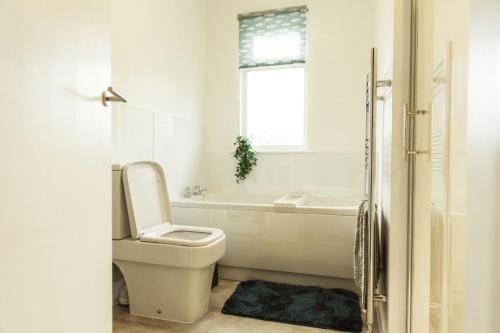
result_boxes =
[219,266,359,293]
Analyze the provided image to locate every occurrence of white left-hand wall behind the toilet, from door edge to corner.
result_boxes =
[111,0,206,198]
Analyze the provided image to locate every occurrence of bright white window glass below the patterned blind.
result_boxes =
[245,67,305,147]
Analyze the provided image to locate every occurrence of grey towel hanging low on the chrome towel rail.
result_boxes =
[353,200,383,309]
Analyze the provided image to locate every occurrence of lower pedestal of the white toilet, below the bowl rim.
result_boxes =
[114,260,215,323]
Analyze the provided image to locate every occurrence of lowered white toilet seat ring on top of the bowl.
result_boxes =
[139,222,224,247]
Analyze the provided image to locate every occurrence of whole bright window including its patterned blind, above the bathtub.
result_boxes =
[239,7,307,151]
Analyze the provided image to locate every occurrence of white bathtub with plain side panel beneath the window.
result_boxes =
[171,192,360,280]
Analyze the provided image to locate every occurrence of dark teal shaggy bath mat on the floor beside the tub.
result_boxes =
[222,280,363,332]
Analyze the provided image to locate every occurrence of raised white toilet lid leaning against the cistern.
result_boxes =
[123,161,172,239]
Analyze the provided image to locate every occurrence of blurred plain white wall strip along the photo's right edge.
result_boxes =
[465,0,500,333]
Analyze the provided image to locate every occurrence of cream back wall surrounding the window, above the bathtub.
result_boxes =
[205,0,374,193]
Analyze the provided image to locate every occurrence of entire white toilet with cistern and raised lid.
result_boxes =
[113,162,226,323]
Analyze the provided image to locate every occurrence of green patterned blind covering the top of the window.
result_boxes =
[238,6,307,68]
